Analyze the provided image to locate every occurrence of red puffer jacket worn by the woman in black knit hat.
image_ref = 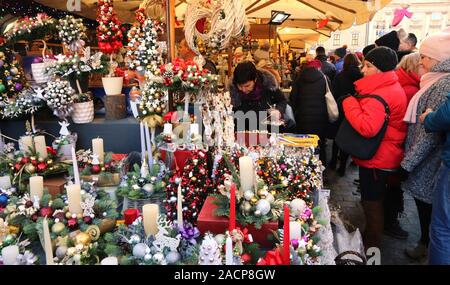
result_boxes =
[343,71,407,169]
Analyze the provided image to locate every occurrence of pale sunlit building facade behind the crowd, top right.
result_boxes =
[318,0,450,52]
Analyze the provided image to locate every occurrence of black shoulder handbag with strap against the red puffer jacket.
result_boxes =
[335,95,391,160]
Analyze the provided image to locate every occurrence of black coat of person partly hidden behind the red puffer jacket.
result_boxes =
[329,67,364,139]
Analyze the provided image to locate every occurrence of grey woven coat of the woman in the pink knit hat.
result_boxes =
[401,59,450,204]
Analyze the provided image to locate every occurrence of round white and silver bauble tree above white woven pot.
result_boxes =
[44,80,75,120]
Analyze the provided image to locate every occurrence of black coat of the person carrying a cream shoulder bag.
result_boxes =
[290,67,329,137]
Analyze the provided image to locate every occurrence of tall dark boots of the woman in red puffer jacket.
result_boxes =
[361,201,384,250]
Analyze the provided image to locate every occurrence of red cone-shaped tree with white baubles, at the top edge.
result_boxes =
[97,0,123,54]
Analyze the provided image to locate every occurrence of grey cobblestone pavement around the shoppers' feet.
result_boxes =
[325,156,426,265]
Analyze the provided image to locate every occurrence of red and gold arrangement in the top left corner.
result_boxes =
[5,13,56,43]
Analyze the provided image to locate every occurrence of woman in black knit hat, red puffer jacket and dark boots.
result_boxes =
[342,47,407,249]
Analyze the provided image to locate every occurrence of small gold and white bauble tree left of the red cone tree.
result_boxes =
[57,15,86,52]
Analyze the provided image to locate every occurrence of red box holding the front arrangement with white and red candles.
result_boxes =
[197,196,278,248]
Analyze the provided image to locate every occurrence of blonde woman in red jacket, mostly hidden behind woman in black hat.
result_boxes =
[395,52,420,103]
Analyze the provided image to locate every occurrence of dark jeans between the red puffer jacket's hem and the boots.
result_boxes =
[359,166,391,201]
